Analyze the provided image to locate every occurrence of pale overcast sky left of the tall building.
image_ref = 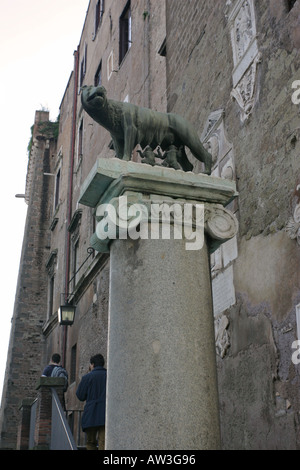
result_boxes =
[0,0,89,399]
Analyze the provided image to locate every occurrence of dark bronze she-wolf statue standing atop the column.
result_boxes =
[81,86,212,175]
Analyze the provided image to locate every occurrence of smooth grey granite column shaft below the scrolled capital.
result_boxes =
[106,233,220,450]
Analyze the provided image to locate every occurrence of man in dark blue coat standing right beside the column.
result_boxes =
[76,354,106,450]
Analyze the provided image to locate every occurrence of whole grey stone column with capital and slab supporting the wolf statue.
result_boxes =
[80,159,237,450]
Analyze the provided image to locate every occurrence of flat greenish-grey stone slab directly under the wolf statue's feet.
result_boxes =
[79,158,237,207]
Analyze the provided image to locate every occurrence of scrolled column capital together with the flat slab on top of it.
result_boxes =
[79,159,238,252]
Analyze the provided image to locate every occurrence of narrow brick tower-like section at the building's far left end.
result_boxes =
[1,112,53,448]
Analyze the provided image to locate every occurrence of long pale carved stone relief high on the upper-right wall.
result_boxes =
[225,0,261,121]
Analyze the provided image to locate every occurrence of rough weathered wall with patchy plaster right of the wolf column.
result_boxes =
[167,0,300,449]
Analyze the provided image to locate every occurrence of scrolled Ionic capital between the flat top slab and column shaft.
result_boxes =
[91,192,238,252]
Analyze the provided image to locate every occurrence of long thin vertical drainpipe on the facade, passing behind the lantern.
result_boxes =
[62,46,79,367]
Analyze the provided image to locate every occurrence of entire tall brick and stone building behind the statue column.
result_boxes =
[0,0,300,449]
